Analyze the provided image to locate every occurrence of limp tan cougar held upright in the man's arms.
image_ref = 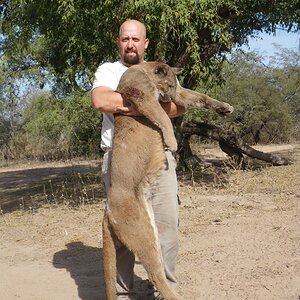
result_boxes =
[103,62,233,300]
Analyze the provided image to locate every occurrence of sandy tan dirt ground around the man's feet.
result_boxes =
[0,145,300,300]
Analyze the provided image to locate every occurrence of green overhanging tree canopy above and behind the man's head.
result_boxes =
[0,0,299,94]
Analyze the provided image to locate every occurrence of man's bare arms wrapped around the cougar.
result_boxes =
[92,86,185,118]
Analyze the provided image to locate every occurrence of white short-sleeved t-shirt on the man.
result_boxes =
[93,61,127,151]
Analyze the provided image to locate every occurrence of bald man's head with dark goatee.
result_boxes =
[117,21,149,67]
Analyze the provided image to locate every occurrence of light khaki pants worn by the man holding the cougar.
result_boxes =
[102,151,179,293]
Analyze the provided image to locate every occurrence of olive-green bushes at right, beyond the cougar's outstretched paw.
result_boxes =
[203,49,300,143]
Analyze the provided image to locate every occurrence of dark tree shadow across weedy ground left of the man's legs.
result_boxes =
[0,164,104,212]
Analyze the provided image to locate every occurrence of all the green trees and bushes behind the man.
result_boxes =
[0,0,300,158]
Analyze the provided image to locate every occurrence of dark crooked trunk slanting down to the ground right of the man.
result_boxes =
[182,121,291,166]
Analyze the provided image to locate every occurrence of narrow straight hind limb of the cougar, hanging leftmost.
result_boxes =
[102,213,116,300]
